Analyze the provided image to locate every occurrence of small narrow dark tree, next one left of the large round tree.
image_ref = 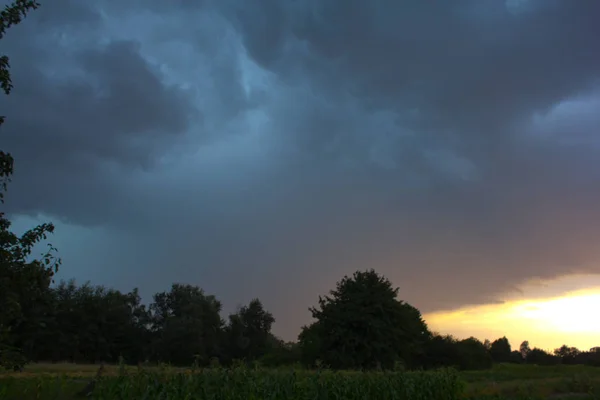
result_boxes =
[225,299,275,361]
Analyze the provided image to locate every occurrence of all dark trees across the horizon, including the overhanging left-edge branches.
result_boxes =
[0,0,600,369]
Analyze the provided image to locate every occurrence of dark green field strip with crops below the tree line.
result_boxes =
[0,364,600,400]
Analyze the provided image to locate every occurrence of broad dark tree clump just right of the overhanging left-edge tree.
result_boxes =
[18,281,149,363]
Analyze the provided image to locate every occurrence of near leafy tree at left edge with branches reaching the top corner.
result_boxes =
[0,0,60,367]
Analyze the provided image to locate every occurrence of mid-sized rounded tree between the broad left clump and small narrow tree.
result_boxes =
[150,284,224,365]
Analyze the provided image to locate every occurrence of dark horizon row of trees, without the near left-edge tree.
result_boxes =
[2,266,600,370]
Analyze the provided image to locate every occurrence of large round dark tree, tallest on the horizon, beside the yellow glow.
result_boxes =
[299,270,430,369]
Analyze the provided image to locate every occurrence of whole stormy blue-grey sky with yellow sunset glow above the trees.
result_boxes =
[0,0,600,348]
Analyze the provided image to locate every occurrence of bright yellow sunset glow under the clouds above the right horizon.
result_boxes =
[425,288,600,350]
